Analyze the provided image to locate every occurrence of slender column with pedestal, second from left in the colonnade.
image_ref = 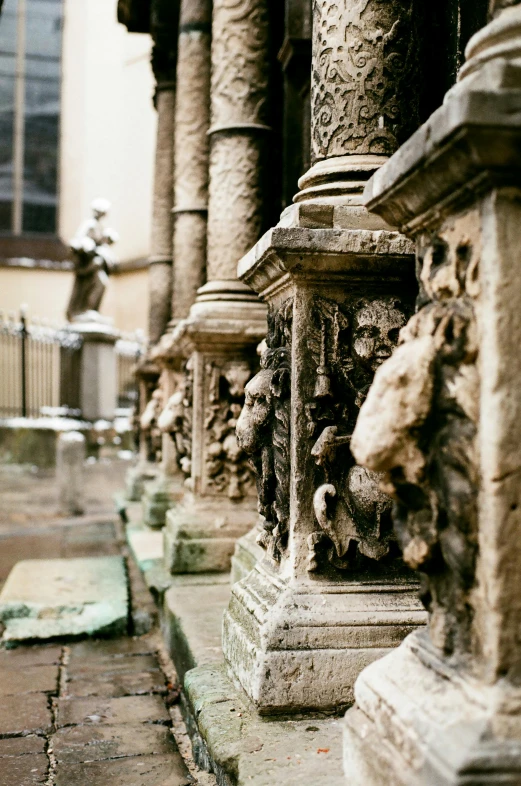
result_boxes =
[143,0,212,527]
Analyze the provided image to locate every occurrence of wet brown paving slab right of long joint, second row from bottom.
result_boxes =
[52,723,177,764]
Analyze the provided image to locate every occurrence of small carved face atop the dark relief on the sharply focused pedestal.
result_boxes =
[353,300,406,371]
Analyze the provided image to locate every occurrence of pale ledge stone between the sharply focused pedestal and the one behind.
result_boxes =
[164,576,230,681]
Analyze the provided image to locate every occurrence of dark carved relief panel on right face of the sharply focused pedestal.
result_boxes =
[306,296,406,572]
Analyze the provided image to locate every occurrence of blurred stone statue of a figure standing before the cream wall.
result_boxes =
[67,199,118,322]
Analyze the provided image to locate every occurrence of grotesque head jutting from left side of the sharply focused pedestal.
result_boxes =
[237,369,273,454]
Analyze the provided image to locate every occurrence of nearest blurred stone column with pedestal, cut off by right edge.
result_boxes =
[345,2,521,786]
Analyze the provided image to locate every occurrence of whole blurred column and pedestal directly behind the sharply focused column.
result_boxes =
[161,0,271,573]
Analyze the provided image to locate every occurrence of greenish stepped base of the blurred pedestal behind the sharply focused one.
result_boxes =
[164,495,258,573]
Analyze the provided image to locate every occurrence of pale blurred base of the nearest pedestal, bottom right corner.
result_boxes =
[344,631,521,786]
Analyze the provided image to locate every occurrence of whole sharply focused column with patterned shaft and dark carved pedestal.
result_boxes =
[219,0,425,713]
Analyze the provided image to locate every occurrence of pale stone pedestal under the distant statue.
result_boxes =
[72,312,118,420]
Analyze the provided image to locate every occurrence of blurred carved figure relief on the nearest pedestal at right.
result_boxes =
[352,214,480,653]
